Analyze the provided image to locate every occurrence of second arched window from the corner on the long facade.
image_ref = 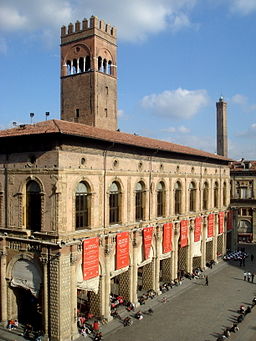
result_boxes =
[109,181,121,224]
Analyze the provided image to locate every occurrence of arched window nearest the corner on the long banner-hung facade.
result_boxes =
[76,182,91,229]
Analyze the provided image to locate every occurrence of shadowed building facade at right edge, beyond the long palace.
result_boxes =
[230,159,256,243]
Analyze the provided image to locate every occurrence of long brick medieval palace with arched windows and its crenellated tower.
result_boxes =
[0,17,232,341]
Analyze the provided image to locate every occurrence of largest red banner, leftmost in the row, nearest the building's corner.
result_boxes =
[83,237,99,280]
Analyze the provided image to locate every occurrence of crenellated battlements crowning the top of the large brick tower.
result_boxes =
[61,16,116,38]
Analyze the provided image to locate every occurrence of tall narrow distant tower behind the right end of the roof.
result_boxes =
[216,96,228,157]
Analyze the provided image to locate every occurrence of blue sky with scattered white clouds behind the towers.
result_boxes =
[0,0,256,160]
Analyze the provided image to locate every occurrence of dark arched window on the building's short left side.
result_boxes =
[26,180,42,231]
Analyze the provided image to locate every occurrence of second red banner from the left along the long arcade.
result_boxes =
[116,232,130,270]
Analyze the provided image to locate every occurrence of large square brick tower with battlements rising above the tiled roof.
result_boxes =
[61,16,117,130]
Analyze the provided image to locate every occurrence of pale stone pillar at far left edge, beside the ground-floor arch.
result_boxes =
[0,241,8,322]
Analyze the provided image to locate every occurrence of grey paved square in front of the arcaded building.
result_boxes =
[0,245,256,341]
